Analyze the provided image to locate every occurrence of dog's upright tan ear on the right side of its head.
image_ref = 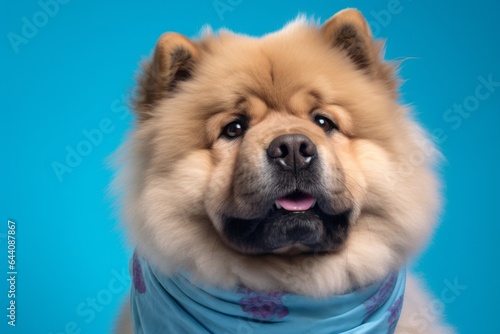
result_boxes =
[321,8,398,93]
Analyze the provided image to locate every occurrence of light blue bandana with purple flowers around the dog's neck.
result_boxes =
[131,254,406,334]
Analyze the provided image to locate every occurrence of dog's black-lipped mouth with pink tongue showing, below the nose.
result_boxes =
[223,190,351,254]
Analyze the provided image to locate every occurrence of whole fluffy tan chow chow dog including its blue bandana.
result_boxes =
[115,9,452,334]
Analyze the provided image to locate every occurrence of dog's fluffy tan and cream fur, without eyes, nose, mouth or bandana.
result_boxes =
[115,9,449,333]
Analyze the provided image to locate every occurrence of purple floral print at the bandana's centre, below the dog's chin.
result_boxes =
[236,287,289,319]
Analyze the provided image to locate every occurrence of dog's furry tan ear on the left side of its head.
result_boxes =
[135,33,200,120]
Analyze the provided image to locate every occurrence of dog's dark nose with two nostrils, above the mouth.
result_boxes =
[267,134,317,174]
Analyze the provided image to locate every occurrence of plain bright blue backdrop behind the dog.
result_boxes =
[0,0,500,334]
